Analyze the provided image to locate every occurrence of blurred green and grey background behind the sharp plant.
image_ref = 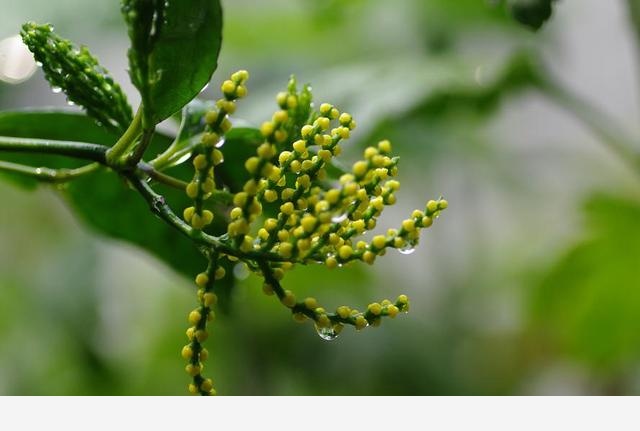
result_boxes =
[0,0,640,395]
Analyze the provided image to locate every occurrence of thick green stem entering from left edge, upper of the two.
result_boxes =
[0,136,108,164]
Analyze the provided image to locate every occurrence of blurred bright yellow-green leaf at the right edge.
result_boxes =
[532,196,640,373]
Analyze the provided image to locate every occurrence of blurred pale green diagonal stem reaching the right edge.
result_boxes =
[538,80,640,176]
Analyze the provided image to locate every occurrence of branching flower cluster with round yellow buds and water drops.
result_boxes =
[183,71,448,394]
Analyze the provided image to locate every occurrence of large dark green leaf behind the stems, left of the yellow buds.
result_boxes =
[0,111,232,294]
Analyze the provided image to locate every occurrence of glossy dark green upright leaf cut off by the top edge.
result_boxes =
[122,0,222,127]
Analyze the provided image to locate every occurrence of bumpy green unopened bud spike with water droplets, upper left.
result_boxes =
[20,22,133,132]
